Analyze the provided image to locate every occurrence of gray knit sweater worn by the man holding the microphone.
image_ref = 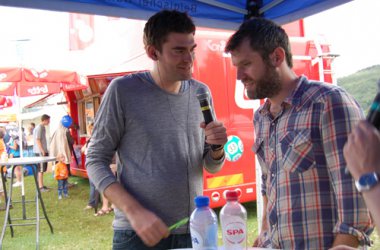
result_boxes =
[86,72,224,234]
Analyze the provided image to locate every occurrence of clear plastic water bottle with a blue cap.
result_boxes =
[190,196,218,250]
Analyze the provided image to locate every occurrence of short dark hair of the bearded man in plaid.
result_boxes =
[225,18,293,68]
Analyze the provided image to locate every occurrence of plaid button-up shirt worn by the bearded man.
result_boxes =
[254,76,373,249]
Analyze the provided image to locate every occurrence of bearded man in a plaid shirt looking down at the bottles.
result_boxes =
[225,18,373,249]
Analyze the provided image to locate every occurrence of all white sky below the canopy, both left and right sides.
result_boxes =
[0,0,380,77]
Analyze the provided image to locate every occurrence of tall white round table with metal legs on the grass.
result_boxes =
[0,156,56,249]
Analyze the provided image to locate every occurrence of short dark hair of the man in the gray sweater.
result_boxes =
[144,10,195,52]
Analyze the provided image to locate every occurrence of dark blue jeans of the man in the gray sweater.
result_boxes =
[112,230,192,250]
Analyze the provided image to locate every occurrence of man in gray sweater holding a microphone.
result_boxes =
[86,10,227,249]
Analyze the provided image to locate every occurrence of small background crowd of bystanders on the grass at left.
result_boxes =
[0,114,116,216]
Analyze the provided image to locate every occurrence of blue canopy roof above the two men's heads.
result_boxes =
[0,0,352,29]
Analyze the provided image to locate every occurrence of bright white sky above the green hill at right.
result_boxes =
[304,0,380,77]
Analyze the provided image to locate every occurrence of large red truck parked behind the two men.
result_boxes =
[66,20,334,207]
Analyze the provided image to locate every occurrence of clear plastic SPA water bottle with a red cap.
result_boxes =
[219,190,247,250]
